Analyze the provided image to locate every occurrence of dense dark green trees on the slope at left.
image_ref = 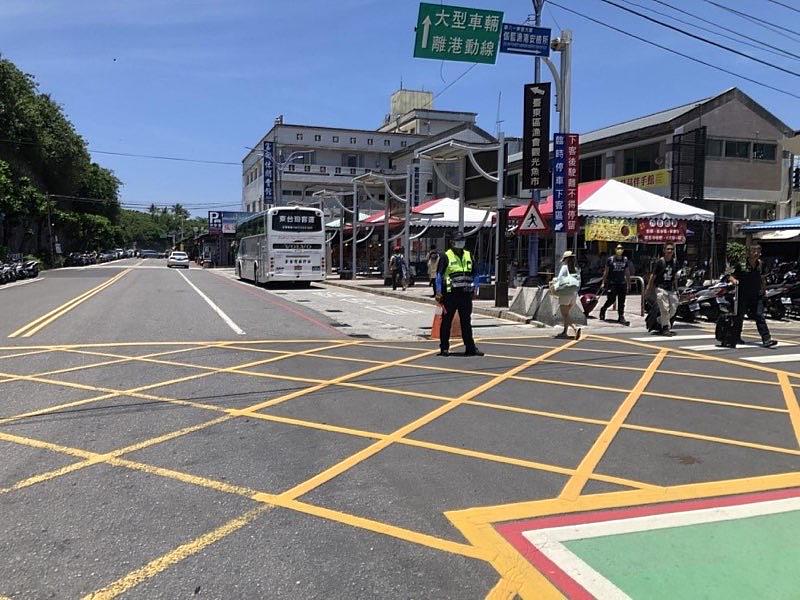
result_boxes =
[0,57,121,255]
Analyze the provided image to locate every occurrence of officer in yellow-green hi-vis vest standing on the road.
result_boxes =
[436,233,483,356]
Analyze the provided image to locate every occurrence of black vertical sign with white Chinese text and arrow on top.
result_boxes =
[522,83,550,190]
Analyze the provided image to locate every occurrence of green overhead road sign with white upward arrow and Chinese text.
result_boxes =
[414,3,503,64]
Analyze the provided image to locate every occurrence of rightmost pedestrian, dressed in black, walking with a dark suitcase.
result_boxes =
[722,245,778,348]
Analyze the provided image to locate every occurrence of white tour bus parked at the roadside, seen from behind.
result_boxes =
[236,206,325,286]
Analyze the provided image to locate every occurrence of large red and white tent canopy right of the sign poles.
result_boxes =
[510,179,714,221]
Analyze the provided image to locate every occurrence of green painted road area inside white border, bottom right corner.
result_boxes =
[563,511,800,600]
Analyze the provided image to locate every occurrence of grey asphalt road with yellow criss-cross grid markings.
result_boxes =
[0,260,800,599]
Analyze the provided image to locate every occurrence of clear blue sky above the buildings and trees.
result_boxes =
[0,0,800,214]
